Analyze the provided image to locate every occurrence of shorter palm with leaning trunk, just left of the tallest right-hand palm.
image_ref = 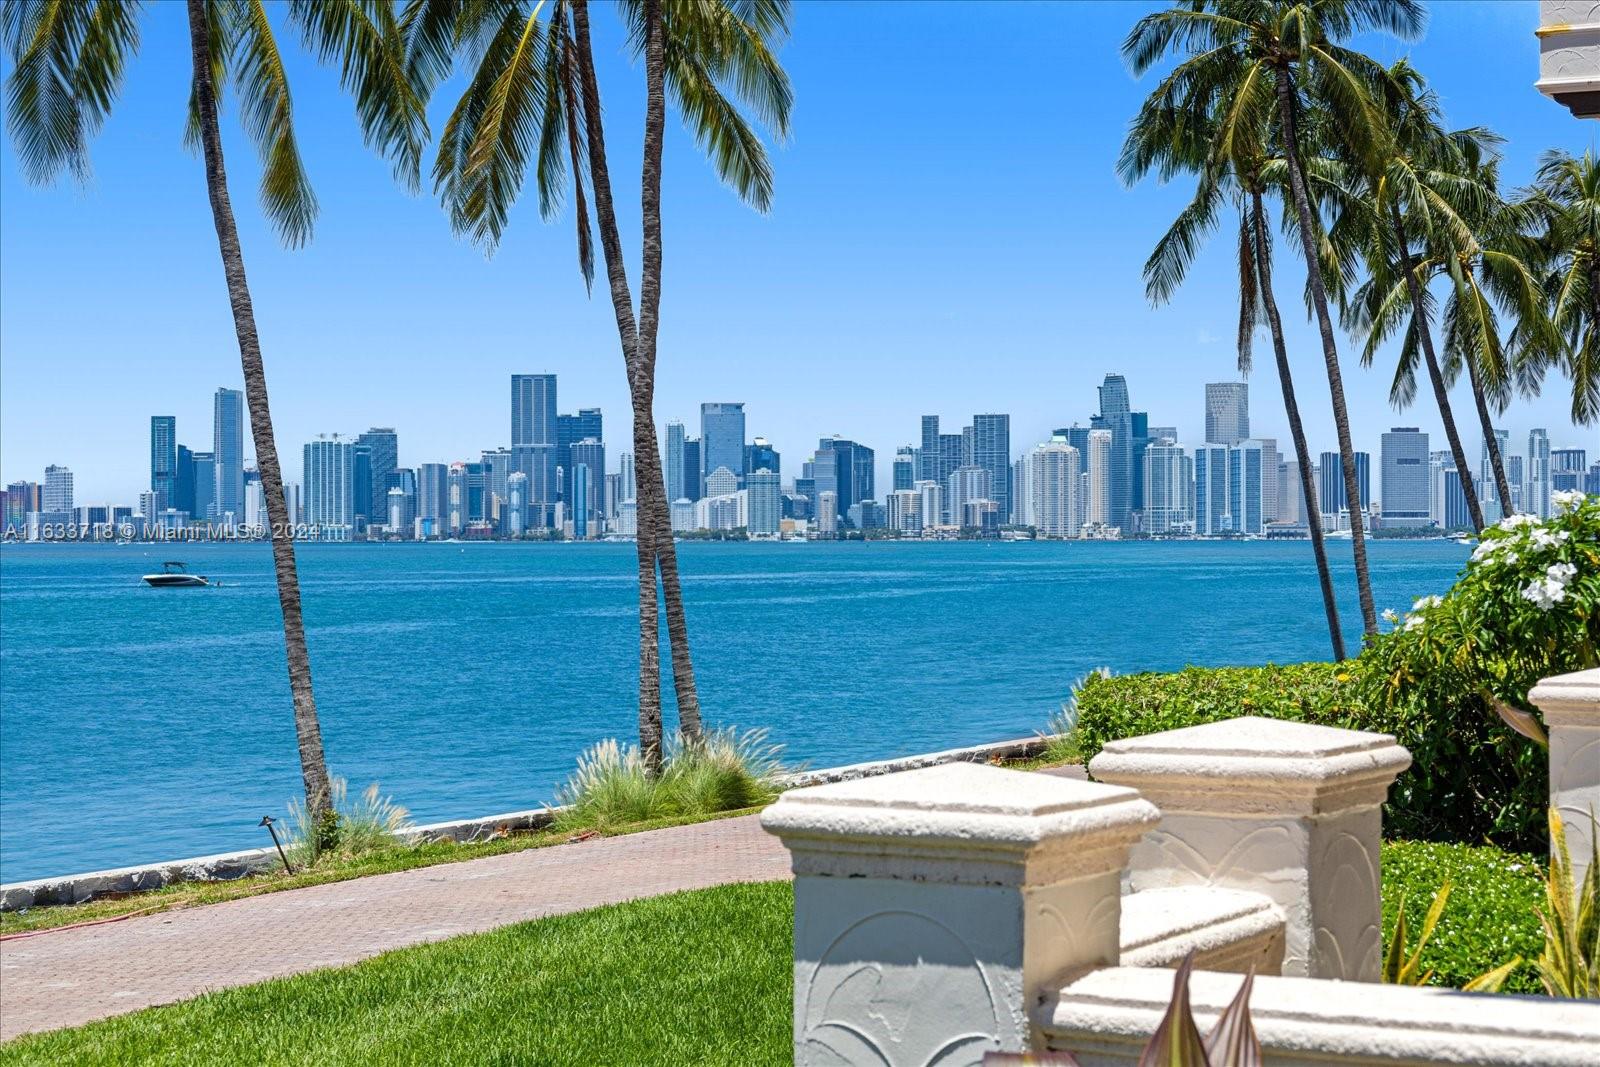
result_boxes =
[1117,90,1344,661]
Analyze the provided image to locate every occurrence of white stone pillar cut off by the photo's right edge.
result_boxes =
[1528,669,1600,885]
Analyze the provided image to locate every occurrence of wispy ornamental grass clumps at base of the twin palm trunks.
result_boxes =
[555,728,784,830]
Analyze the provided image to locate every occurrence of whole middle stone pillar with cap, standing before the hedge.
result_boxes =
[1090,717,1411,982]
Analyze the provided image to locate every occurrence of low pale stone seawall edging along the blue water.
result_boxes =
[0,737,1046,912]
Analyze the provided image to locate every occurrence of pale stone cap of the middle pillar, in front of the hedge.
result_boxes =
[1090,715,1411,814]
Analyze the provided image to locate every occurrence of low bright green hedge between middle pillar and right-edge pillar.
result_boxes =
[1382,841,1544,993]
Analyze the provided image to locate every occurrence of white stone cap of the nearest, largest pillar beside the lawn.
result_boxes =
[762,763,1160,880]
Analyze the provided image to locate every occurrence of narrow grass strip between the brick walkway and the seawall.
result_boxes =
[0,808,757,936]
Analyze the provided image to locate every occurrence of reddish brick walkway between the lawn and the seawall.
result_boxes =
[0,816,789,1040]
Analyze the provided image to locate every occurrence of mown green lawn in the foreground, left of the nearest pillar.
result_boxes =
[0,883,794,1067]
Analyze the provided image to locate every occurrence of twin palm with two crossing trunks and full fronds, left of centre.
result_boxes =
[400,0,792,766]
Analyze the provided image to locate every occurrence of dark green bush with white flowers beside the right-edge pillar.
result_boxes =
[1355,493,1600,848]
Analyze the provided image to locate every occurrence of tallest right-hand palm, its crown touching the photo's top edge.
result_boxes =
[1122,0,1424,635]
